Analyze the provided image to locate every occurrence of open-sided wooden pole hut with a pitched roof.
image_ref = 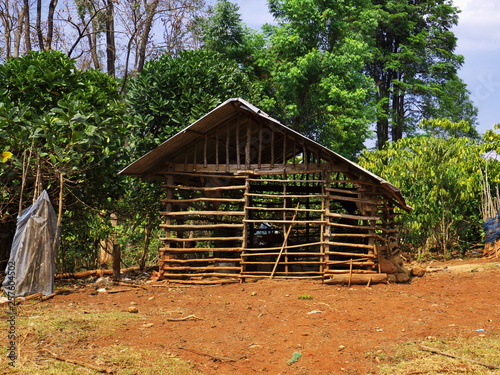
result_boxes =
[120,99,410,280]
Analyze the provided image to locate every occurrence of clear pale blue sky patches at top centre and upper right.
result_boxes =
[232,0,500,133]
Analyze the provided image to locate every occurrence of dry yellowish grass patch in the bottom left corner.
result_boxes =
[0,302,203,375]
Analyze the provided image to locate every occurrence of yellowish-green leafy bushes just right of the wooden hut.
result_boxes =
[360,120,486,257]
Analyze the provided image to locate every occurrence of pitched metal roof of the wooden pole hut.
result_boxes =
[119,98,411,210]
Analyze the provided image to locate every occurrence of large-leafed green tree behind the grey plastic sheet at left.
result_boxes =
[0,51,127,272]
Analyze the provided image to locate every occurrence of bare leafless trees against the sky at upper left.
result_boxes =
[0,0,205,81]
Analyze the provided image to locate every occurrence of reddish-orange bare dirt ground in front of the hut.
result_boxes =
[13,259,500,375]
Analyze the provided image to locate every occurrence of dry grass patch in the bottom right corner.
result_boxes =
[376,336,500,375]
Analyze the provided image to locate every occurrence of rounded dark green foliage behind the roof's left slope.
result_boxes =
[127,50,256,156]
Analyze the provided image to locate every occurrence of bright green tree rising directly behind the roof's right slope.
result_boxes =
[257,0,376,157]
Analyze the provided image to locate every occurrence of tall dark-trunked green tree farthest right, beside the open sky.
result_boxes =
[366,0,477,149]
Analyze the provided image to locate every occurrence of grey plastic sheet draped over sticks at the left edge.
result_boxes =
[3,190,59,297]
